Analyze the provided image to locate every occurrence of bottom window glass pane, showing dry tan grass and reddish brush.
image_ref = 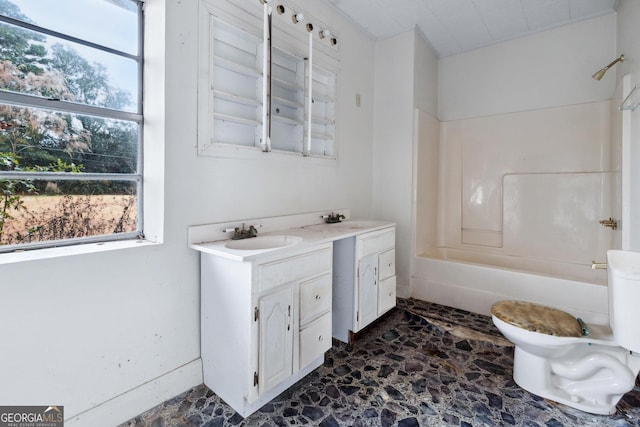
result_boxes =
[0,179,137,247]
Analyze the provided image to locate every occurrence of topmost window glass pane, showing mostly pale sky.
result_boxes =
[0,0,138,55]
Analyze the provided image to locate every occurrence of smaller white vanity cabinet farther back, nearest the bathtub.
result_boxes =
[332,226,396,342]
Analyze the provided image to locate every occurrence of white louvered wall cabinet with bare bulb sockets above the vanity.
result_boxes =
[198,0,339,159]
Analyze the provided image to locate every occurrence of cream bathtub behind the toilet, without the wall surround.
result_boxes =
[410,248,609,324]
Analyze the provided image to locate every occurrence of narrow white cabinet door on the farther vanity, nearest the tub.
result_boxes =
[354,253,378,332]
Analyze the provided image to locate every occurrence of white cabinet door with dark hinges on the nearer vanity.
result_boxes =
[258,286,294,394]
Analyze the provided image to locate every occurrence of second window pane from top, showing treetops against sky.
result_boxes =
[0,20,138,112]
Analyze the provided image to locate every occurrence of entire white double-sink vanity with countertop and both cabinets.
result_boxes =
[189,211,395,417]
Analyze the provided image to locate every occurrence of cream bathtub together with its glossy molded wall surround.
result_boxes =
[410,100,621,324]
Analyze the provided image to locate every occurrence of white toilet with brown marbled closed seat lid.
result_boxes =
[491,250,640,415]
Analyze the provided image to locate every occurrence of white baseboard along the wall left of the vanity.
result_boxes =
[65,358,202,427]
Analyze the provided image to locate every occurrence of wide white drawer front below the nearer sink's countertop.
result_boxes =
[258,248,332,292]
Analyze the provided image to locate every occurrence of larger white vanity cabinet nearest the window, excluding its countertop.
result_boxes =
[201,242,332,417]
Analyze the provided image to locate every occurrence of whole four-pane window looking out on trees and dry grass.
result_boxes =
[0,0,143,252]
